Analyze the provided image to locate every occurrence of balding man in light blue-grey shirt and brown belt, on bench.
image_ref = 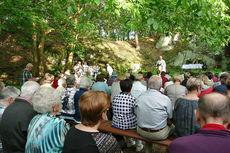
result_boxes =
[135,75,175,140]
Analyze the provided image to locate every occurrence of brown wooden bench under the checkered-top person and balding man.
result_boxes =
[98,121,173,153]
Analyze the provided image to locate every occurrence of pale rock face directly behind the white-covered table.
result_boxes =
[171,50,216,68]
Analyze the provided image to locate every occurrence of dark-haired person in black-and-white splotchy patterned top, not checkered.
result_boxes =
[61,75,77,120]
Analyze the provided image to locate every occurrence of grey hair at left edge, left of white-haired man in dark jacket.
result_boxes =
[0,86,20,101]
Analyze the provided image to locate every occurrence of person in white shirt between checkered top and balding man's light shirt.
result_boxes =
[131,73,147,98]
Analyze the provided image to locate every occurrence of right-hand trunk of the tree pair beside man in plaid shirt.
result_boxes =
[38,28,46,76]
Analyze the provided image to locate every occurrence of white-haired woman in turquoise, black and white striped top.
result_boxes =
[25,88,70,153]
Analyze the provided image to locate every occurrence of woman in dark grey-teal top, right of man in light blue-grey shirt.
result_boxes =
[173,78,202,137]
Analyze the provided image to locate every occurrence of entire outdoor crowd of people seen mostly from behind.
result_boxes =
[0,62,230,153]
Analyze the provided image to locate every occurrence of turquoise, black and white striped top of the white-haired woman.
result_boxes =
[25,113,70,153]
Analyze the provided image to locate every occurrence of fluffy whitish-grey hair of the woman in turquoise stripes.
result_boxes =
[32,88,61,114]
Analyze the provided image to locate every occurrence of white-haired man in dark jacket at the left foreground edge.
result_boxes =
[0,81,40,153]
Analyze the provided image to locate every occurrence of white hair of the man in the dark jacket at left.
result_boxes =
[21,81,40,99]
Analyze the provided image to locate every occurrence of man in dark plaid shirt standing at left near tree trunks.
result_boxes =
[19,63,39,86]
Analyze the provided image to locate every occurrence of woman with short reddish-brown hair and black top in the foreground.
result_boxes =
[63,91,121,153]
